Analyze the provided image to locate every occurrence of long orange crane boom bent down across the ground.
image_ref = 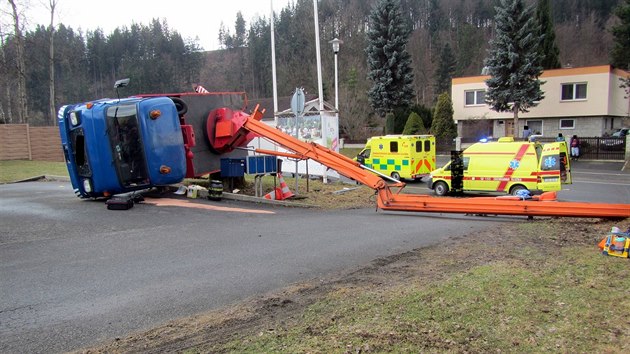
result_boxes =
[217,106,630,218]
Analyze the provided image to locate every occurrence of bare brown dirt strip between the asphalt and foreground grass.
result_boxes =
[75,214,630,353]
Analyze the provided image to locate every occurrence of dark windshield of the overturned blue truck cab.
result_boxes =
[107,104,149,187]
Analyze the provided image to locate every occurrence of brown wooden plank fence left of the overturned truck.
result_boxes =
[0,124,64,162]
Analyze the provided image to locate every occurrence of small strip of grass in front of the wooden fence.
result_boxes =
[0,160,68,183]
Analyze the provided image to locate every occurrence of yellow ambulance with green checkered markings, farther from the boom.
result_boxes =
[355,135,435,180]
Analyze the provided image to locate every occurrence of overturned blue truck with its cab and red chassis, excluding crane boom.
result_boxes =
[57,81,253,198]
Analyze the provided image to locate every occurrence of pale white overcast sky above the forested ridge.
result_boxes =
[21,0,294,50]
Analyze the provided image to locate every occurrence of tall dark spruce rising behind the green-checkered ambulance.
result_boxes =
[366,0,414,117]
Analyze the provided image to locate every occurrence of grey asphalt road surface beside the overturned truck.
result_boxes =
[0,161,630,353]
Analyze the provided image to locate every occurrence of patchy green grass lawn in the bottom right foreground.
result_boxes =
[218,230,630,353]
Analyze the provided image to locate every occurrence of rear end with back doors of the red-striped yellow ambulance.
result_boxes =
[538,142,571,191]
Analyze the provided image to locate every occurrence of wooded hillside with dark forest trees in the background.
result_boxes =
[0,0,629,139]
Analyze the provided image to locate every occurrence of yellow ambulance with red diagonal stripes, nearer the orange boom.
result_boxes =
[428,137,571,196]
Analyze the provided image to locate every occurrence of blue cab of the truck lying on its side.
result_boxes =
[57,97,186,198]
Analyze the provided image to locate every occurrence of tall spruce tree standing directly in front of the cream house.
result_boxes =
[484,0,544,136]
